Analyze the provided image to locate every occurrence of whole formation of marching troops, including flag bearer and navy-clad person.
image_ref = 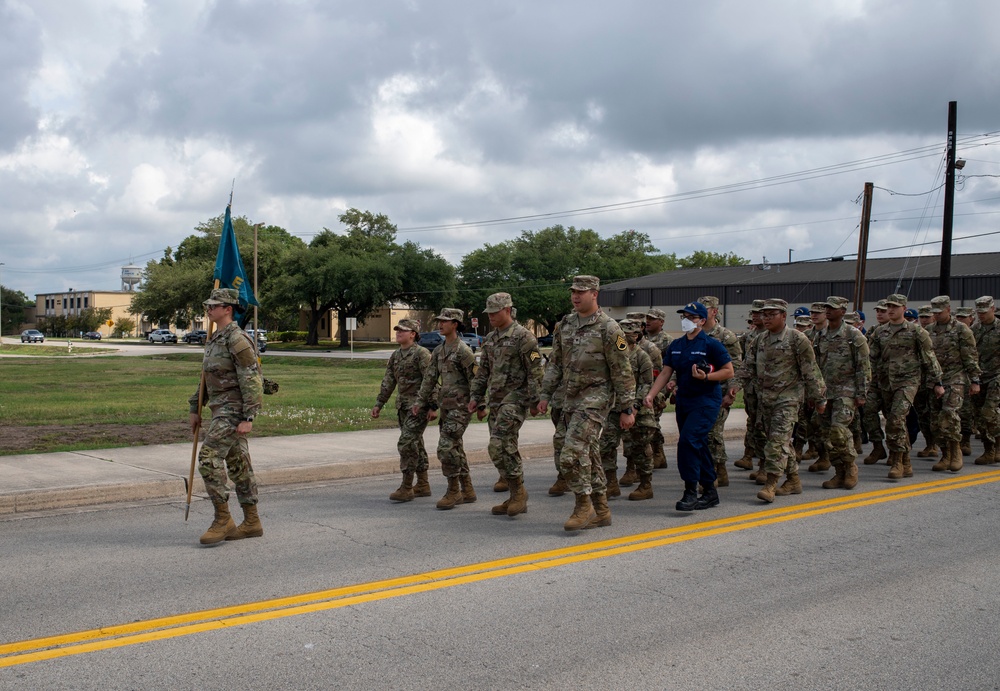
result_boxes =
[191,276,1000,544]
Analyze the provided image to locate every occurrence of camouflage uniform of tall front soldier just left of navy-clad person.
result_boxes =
[541,309,635,495]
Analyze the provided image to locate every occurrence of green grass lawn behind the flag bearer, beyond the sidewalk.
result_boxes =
[0,353,396,455]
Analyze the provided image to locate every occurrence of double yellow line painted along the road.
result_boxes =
[0,472,1000,667]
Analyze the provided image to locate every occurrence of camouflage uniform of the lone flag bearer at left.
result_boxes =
[188,322,264,505]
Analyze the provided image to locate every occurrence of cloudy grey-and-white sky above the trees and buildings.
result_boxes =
[0,0,1000,296]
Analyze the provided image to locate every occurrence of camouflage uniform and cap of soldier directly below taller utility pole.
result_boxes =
[927,295,980,444]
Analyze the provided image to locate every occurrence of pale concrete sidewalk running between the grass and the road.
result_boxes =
[0,409,746,514]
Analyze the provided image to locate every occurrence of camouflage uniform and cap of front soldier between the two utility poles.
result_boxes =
[868,294,941,466]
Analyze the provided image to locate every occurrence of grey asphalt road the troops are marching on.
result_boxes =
[0,440,1000,689]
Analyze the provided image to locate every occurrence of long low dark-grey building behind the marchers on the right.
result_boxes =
[600,252,1000,331]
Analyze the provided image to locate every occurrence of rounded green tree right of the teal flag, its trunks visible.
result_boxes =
[275,208,455,348]
